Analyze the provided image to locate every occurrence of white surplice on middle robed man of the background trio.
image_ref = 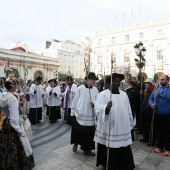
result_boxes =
[46,86,61,106]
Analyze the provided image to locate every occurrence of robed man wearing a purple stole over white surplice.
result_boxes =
[63,76,77,125]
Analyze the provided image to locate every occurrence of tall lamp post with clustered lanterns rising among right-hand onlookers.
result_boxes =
[134,42,146,138]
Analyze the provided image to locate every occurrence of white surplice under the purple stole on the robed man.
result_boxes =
[63,83,77,108]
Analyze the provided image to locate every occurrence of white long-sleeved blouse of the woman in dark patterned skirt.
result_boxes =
[0,92,22,132]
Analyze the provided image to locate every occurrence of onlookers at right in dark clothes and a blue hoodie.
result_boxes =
[96,75,170,156]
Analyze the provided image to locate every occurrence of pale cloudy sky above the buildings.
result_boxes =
[0,0,170,51]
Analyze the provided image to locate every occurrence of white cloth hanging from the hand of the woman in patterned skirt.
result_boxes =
[20,134,32,157]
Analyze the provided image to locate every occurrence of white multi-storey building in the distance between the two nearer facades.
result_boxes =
[39,40,85,78]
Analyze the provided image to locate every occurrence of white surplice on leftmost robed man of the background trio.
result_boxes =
[29,84,43,108]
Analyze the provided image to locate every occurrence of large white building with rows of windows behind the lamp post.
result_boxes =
[90,18,170,83]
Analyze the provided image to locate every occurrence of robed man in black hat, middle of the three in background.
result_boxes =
[46,79,61,123]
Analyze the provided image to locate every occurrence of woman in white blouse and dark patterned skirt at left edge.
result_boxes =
[0,79,35,170]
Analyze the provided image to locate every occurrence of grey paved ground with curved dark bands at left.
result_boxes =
[31,113,170,170]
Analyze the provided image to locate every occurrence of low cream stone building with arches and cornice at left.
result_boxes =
[0,46,59,80]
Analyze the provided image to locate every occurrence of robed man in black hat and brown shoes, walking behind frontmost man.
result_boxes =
[71,72,99,156]
